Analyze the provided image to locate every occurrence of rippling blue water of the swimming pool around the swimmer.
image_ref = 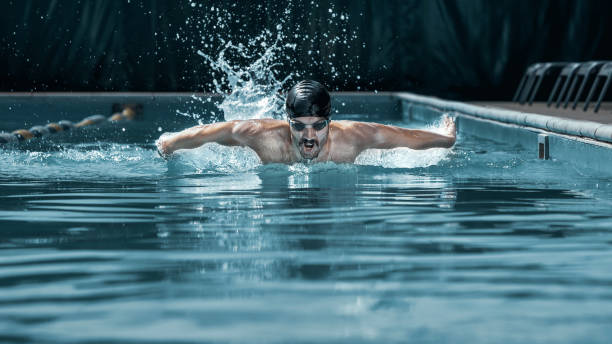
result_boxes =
[0,94,612,343]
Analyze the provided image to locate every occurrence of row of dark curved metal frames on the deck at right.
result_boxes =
[512,61,612,113]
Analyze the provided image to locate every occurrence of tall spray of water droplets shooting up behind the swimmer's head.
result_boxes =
[176,0,362,123]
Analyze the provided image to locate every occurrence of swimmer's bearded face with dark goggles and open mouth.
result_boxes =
[289,117,329,160]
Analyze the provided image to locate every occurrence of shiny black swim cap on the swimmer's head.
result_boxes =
[285,80,331,118]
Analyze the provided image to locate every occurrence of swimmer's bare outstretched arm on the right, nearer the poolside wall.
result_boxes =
[362,117,457,149]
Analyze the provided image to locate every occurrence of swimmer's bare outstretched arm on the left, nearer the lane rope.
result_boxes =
[156,121,255,157]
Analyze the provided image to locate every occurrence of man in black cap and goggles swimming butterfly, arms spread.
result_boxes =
[156,80,456,164]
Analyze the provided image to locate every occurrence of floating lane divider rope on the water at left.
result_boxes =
[0,104,143,144]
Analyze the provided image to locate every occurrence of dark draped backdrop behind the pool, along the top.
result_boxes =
[0,0,612,100]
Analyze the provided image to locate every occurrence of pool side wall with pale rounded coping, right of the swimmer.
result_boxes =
[394,92,612,172]
